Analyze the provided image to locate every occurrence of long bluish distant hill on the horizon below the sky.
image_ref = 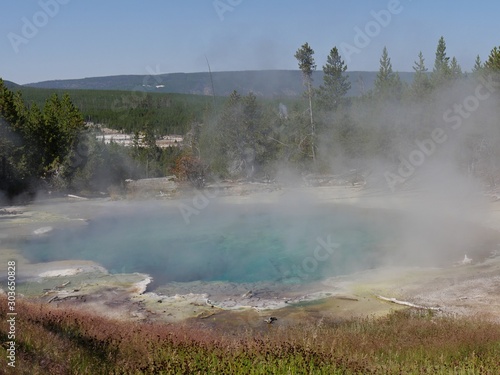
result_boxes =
[24,70,413,97]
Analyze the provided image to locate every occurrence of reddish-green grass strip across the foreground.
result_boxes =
[0,297,500,375]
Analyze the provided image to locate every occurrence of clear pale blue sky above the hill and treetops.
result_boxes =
[0,0,500,84]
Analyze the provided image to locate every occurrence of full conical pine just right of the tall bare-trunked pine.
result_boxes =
[318,47,351,110]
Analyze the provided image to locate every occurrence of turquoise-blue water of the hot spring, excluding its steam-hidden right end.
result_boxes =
[22,205,389,284]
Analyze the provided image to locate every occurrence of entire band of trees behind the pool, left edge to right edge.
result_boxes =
[0,37,500,201]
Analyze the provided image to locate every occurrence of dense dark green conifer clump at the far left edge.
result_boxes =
[0,79,109,196]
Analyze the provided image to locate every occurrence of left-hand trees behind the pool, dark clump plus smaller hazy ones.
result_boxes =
[0,83,188,199]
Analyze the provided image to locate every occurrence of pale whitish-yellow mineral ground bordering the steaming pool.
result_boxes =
[0,187,500,322]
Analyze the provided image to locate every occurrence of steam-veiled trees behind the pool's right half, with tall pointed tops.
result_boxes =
[185,37,500,188]
